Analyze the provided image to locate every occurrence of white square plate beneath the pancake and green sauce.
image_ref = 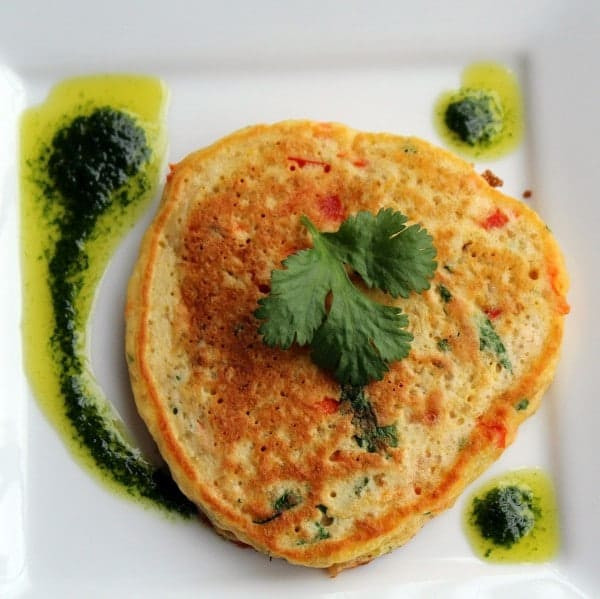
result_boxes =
[0,0,600,598]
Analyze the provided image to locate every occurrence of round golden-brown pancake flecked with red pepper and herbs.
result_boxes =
[126,121,568,574]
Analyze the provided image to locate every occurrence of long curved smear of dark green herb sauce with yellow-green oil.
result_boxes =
[22,76,195,515]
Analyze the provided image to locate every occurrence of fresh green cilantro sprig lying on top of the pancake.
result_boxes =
[254,209,437,386]
